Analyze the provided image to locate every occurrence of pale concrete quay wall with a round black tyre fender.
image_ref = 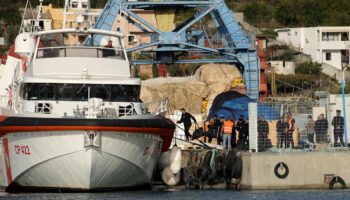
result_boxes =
[240,151,350,190]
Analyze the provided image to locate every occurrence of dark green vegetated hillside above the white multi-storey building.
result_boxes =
[226,0,350,28]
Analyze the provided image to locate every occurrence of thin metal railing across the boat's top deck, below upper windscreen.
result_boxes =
[36,46,125,60]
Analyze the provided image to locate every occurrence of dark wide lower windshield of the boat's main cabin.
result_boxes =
[21,83,140,102]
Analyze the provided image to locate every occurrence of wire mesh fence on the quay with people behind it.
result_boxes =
[249,95,350,152]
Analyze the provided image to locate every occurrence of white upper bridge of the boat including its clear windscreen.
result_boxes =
[27,29,130,79]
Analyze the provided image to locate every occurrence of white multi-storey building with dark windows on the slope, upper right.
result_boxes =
[275,26,350,75]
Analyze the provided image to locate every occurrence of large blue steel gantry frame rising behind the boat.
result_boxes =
[94,0,260,100]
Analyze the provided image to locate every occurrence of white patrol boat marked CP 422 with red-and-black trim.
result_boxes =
[0,1,175,191]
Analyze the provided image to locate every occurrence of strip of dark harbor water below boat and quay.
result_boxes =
[0,189,350,200]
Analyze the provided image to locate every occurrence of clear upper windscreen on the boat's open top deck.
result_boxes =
[36,33,125,60]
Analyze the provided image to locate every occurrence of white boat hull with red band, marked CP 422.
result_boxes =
[0,115,173,191]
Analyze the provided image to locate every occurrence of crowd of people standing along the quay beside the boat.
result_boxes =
[179,109,345,151]
